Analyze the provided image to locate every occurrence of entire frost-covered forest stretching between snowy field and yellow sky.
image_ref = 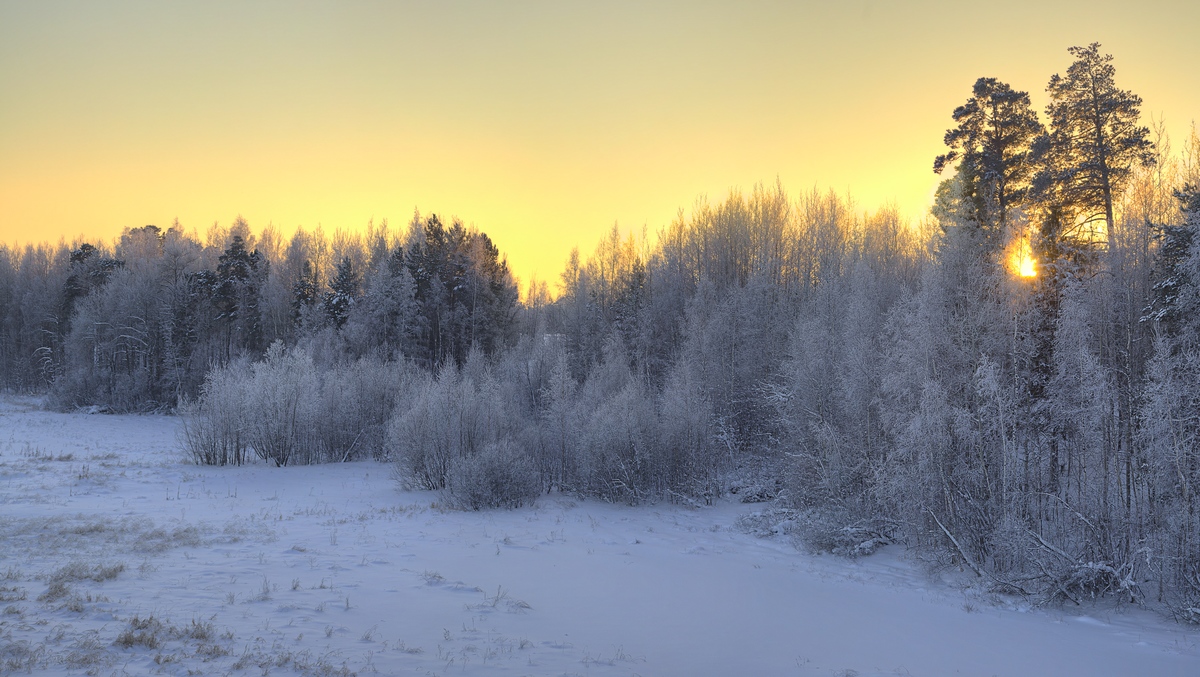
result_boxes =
[7,43,1200,623]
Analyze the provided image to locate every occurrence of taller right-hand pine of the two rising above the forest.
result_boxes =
[1030,42,1156,501]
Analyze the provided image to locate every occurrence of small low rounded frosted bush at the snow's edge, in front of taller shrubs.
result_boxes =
[445,441,541,510]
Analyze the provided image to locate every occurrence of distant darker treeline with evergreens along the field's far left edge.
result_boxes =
[0,215,518,412]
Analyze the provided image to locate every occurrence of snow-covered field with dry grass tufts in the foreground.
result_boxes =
[0,397,1200,676]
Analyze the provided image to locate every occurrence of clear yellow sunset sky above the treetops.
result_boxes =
[0,0,1200,284]
